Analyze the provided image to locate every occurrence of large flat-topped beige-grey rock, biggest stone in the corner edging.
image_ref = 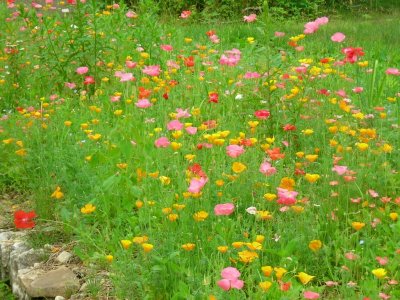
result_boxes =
[20,266,80,298]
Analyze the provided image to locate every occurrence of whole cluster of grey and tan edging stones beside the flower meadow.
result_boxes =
[0,230,80,300]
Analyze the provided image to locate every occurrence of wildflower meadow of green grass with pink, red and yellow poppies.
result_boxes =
[0,0,400,299]
